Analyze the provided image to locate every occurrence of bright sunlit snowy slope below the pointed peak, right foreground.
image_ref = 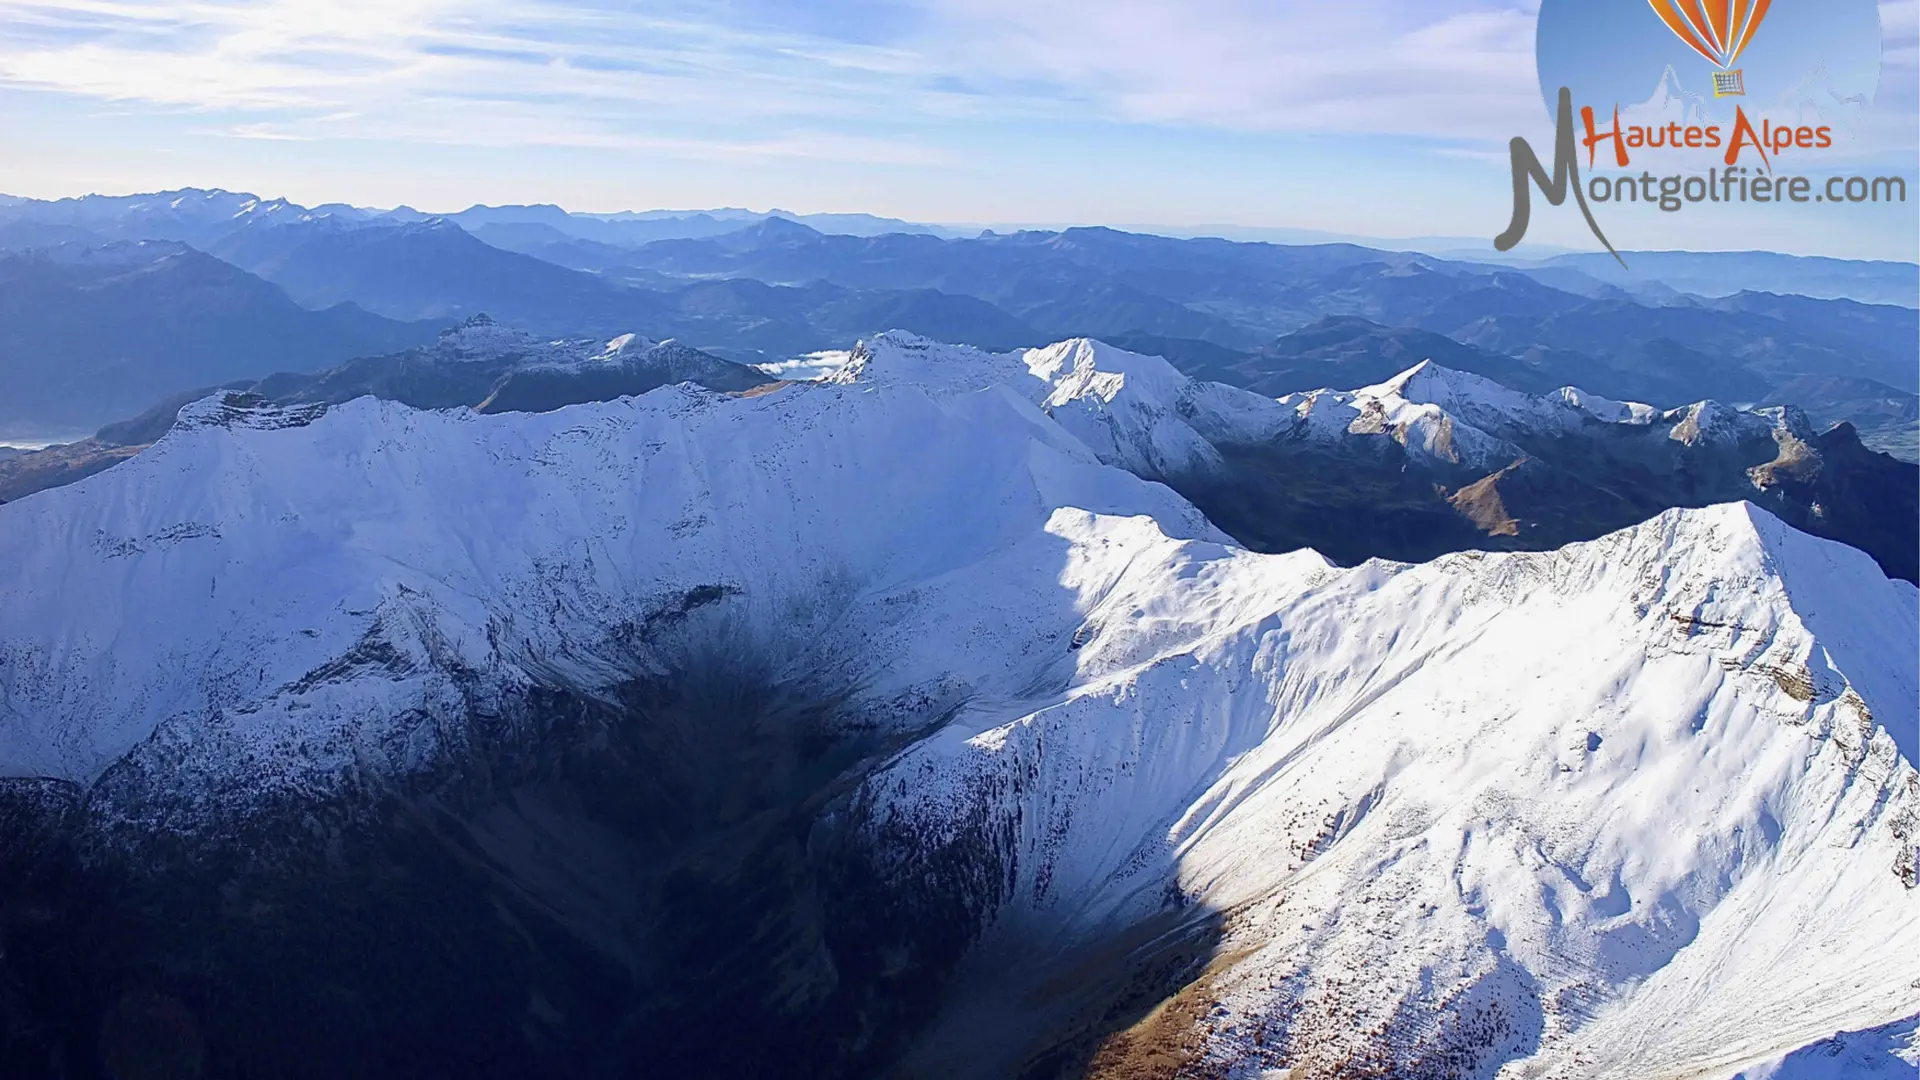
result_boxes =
[874,505,1920,1076]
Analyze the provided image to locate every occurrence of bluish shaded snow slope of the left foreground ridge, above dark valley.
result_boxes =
[0,355,1223,782]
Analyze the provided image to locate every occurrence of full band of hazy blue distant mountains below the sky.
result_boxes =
[0,190,1920,455]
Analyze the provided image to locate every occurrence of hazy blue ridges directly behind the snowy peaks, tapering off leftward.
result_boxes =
[591,225,1920,402]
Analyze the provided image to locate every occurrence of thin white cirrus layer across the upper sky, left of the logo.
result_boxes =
[0,0,1559,153]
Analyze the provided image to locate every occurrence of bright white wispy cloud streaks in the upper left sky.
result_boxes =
[0,0,975,161]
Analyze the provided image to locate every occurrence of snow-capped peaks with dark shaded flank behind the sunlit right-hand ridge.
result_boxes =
[829,334,1920,580]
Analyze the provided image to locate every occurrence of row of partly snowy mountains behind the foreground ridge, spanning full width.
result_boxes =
[0,326,1920,580]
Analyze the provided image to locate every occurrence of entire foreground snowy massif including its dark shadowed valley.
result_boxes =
[0,327,1920,1080]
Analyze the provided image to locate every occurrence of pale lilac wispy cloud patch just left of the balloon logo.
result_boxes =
[913,0,1536,138]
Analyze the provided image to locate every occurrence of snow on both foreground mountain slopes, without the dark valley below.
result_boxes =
[0,334,1920,1080]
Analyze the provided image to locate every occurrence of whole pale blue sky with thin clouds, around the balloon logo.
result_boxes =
[0,0,1920,258]
